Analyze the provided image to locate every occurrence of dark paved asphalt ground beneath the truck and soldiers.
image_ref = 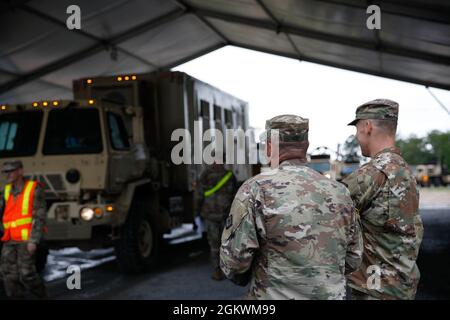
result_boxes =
[0,208,450,300]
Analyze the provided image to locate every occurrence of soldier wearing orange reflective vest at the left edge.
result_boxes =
[0,161,47,299]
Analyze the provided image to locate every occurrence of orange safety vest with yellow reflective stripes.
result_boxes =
[1,180,37,242]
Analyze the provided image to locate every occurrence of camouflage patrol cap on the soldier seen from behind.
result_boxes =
[266,114,309,142]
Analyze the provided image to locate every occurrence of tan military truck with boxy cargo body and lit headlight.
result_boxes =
[0,72,251,272]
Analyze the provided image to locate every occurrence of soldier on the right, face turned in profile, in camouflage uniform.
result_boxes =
[343,99,423,299]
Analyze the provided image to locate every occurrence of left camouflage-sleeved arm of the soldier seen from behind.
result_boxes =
[220,180,259,285]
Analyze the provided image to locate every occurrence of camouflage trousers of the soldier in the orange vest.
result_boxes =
[1,242,46,299]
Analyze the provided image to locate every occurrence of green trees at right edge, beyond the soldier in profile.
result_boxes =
[397,130,450,168]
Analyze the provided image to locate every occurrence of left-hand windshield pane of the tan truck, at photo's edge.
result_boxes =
[0,111,43,158]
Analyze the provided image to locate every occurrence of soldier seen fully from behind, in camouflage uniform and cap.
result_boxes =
[220,115,363,299]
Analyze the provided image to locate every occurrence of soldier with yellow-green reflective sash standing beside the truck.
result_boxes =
[199,163,236,280]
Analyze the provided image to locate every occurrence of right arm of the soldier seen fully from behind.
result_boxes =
[345,207,364,274]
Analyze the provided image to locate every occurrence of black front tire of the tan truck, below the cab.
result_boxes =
[115,205,160,273]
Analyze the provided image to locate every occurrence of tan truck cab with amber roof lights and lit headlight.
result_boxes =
[0,99,145,247]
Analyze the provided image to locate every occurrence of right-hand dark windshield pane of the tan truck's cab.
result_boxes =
[42,109,103,155]
